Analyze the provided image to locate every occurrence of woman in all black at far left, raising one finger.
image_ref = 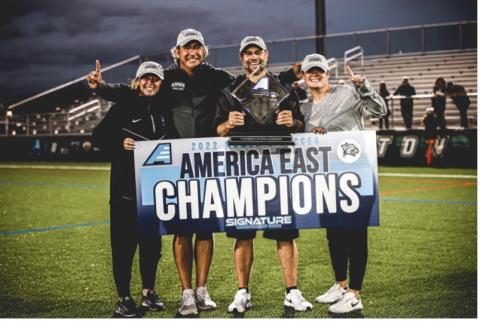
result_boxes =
[87,60,169,317]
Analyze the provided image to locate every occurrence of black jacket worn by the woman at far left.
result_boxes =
[92,84,171,203]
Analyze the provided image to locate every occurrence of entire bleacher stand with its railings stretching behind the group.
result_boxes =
[0,21,477,136]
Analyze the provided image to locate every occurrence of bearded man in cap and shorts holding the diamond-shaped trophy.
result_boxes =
[215,36,312,313]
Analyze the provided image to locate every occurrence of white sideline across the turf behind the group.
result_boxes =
[0,164,477,179]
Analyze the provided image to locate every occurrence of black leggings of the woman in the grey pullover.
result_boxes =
[327,227,368,291]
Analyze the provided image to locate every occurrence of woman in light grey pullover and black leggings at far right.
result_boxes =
[300,54,387,313]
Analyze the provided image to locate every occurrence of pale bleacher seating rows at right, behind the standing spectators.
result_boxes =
[262,50,477,129]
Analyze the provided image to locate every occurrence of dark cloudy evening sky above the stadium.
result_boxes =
[0,0,476,103]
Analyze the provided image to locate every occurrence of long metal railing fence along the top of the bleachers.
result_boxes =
[207,21,477,67]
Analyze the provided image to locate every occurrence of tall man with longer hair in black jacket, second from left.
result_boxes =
[164,29,234,316]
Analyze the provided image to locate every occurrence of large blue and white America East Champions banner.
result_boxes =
[135,131,379,234]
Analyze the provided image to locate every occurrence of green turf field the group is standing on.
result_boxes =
[0,164,477,318]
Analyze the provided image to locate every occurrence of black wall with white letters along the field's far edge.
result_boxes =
[0,129,477,168]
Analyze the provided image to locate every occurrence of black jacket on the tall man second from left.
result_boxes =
[162,63,235,138]
